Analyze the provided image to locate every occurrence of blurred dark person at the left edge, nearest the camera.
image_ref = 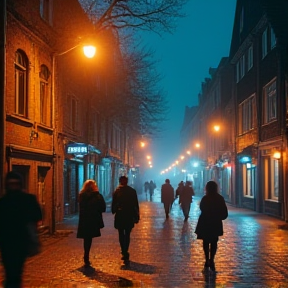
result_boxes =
[0,171,42,288]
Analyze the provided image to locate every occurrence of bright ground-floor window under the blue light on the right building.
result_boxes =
[243,163,256,197]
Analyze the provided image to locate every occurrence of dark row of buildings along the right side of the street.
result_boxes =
[182,0,288,221]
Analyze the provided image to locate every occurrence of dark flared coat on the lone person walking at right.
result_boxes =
[195,193,228,240]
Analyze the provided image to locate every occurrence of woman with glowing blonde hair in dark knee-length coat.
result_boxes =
[77,180,106,266]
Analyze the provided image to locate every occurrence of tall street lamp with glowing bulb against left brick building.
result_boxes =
[51,43,96,233]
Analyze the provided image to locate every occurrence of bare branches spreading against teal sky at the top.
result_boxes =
[79,0,188,33]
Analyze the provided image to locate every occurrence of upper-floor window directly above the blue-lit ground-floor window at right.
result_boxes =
[238,95,256,135]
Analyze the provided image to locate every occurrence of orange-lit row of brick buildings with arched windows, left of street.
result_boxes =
[1,0,133,232]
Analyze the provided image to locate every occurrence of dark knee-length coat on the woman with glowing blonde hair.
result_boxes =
[77,191,106,238]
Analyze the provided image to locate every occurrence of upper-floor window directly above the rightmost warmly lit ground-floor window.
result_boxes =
[263,80,277,124]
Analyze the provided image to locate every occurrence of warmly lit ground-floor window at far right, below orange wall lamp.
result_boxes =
[264,157,279,200]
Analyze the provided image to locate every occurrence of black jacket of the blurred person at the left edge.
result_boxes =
[0,191,42,255]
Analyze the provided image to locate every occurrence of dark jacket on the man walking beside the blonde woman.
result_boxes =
[111,185,140,229]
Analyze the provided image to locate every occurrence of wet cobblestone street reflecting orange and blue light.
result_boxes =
[0,191,288,288]
